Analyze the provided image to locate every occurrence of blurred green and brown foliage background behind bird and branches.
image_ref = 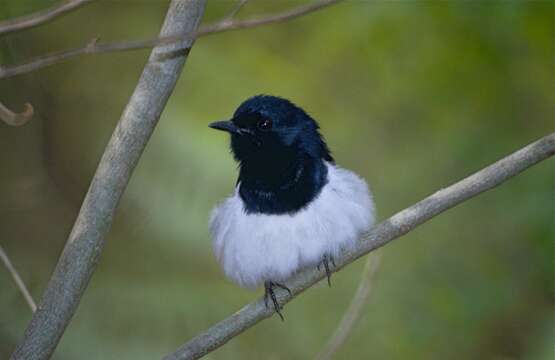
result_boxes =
[0,0,555,359]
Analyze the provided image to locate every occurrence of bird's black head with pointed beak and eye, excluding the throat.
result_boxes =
[210,95,332,163]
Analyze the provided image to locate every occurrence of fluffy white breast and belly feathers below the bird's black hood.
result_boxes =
[210,163,375,289]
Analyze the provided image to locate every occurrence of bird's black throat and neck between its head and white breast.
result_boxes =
[238,153,328,214]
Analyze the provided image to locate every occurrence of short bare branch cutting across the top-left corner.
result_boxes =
[0,0,93,35]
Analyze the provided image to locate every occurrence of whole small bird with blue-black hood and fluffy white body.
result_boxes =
[209,95,375,320]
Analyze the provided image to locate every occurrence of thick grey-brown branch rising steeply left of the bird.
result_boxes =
[11,0,205,360]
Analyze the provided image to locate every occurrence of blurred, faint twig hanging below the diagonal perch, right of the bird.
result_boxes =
[316,252,380,360]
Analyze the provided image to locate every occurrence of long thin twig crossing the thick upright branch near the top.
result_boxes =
[0,0,342,79]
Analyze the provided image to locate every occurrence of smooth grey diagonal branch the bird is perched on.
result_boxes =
[164,133,555,360]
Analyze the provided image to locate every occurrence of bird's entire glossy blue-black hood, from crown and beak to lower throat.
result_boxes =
[210,95,333,214]
